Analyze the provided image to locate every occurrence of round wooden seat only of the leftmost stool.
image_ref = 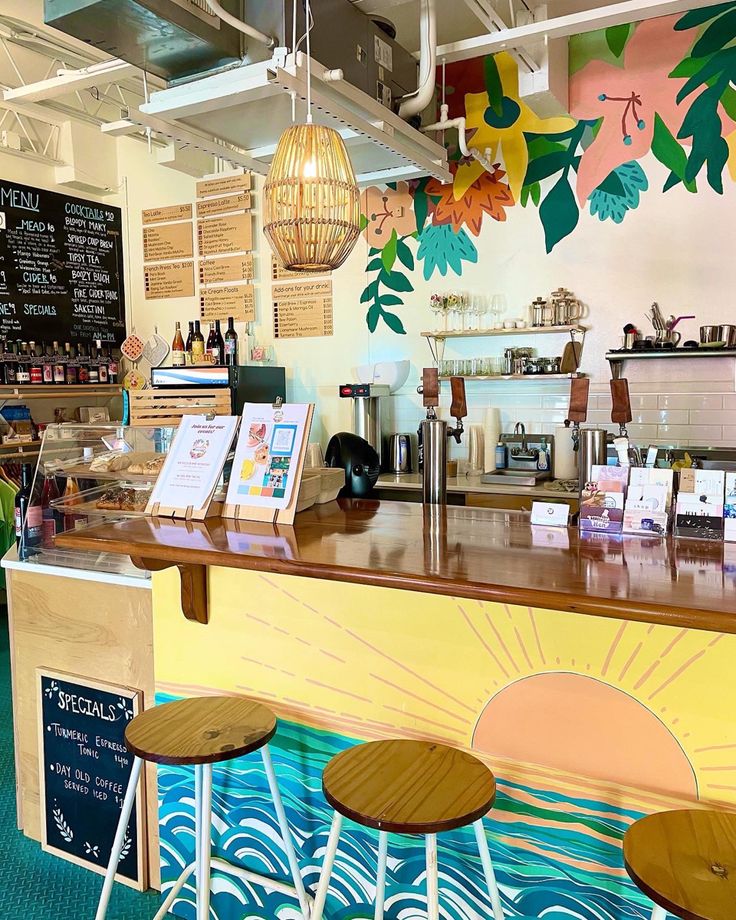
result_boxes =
[125,696,276,765]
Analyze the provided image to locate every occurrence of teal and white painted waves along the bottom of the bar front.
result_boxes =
[157,694,651,920]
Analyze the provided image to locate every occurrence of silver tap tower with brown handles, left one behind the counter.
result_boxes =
[417,367,468,505]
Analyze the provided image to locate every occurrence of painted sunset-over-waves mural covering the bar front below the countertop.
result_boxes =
[153,568,736,920]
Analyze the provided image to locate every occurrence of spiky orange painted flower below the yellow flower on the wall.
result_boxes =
[426,164,514,236]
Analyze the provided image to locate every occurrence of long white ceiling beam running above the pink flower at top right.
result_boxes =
[437,0,732,63]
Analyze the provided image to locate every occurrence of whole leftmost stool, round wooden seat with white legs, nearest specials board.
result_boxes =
[96,696,311,920]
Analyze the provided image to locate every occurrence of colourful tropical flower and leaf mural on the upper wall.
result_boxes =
[361,3,736,334]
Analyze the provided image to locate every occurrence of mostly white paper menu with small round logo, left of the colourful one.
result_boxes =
[146,415,238,514]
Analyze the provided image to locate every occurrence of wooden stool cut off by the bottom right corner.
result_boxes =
[624,809,736,920]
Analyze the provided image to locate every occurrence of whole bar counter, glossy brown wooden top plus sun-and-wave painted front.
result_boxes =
[58,500,736,920]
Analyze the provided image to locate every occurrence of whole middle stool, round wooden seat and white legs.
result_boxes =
[312,740,503,920]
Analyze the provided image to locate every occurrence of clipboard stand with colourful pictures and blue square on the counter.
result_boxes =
[222,401,314,524]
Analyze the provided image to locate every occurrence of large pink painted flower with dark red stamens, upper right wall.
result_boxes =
[570,15,693,205]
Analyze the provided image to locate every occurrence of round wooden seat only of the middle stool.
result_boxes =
[322,740,496,834]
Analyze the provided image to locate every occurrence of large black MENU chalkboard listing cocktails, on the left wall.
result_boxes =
[0,180,125,345]
